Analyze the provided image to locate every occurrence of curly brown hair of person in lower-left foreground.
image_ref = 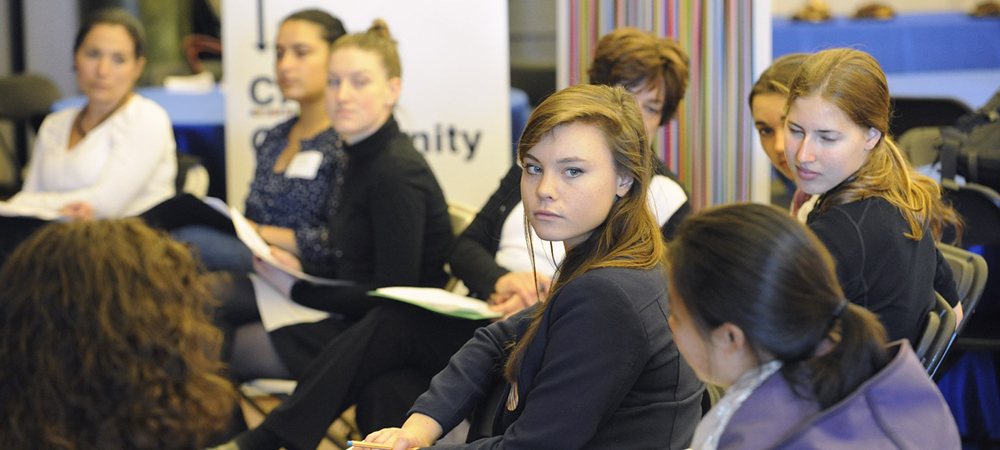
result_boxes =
[0,219,236,450]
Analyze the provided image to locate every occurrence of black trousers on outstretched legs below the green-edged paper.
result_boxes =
[261,302,486,449]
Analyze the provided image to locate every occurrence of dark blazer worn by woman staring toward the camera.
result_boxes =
[410,268,704,450]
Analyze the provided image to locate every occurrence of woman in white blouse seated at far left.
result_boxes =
[11,9,177,220]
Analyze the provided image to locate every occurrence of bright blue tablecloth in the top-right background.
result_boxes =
[772,12,1000,73]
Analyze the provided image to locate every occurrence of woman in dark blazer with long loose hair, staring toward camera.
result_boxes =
[366,85,702,450]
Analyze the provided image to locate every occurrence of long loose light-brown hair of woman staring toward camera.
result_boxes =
[505,85,664,383]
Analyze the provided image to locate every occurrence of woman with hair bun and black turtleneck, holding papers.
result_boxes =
[220,20,454,392]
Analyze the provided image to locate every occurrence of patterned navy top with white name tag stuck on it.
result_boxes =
[246,117,342,268]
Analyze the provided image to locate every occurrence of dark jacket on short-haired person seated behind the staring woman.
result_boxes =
[448,159,691,298]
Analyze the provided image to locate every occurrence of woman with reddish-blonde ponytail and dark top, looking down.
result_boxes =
[785,48,962,343]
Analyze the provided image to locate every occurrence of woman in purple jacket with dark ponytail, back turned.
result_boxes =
[667,204,960,450]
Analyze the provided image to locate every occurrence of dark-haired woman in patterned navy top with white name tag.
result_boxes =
[174,10,345,273]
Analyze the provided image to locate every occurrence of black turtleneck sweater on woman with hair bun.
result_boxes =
[292,117,454,318]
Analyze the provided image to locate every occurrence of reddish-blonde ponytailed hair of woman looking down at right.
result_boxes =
[785,48,961,240]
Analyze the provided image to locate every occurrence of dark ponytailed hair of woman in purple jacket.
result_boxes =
[667,203,889,408]
